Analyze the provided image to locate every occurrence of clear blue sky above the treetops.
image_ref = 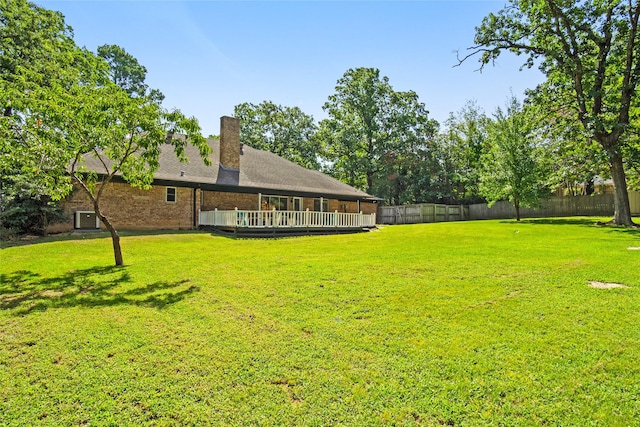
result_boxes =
[40,0,543,135]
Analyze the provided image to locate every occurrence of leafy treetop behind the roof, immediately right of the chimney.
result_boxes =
[234,101,320,170]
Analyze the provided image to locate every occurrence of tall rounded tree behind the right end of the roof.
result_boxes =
[319,68,437,200]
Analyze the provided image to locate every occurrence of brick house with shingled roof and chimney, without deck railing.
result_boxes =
[51,117,380,231]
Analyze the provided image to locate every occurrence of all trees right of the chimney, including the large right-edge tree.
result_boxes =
[236,0,640,226]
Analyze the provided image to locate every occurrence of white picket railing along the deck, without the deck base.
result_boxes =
[200,210,376,229]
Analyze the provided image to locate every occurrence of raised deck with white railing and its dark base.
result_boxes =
[199,210,376,236]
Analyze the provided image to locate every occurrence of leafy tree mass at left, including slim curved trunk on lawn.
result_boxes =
[0,0,209,265]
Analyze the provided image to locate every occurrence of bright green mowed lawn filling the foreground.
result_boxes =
[0,218,640,426]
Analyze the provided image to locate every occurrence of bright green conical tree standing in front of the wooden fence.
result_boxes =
[480,97,548,221]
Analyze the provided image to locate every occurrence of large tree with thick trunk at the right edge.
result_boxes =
[462,0,640,226]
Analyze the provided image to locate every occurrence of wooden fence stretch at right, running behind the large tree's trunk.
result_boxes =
[469,191,640,219]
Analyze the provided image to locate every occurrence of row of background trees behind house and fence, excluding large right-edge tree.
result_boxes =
[235,72,640,224]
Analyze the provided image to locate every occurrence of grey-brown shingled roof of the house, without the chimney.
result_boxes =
[87,139,380,201]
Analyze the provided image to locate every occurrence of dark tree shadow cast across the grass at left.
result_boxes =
[0,266,199,316]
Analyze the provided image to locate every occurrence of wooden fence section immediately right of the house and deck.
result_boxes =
[377,203,469,224]
